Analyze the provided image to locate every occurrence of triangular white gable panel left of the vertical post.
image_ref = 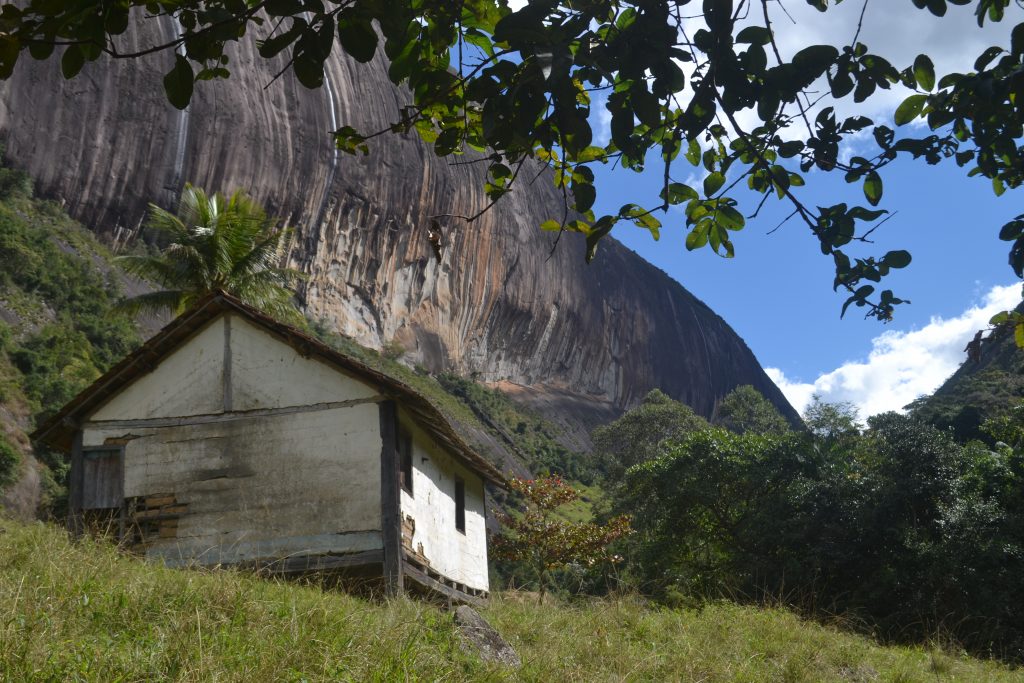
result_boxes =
[90,317,224,420]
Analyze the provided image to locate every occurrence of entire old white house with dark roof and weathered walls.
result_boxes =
[34,293,504,601]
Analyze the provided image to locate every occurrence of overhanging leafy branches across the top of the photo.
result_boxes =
[0,0,1024,323]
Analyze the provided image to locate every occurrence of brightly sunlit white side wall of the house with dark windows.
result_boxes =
[399,411,488,591]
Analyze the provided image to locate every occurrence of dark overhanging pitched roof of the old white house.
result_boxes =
[32,292,505,486]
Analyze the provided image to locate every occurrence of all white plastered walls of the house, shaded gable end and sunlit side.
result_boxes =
[83,315,487,590]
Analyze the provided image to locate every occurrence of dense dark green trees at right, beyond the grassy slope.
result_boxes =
[611,403,1024,660]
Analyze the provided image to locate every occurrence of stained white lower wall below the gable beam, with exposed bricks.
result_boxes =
[83,403,381,564]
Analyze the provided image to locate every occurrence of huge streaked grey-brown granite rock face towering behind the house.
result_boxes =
[0,20,796,444]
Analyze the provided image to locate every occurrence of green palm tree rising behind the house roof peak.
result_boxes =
[116,184,302,319]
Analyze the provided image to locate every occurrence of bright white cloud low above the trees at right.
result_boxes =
[765,284,1021,418]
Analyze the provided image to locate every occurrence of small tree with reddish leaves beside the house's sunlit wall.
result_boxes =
[492,476,632,603]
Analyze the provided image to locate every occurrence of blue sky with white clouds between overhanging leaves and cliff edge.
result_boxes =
[561,0,1024,417]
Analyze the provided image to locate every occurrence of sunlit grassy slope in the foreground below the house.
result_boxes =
[0,521,1021,682]
